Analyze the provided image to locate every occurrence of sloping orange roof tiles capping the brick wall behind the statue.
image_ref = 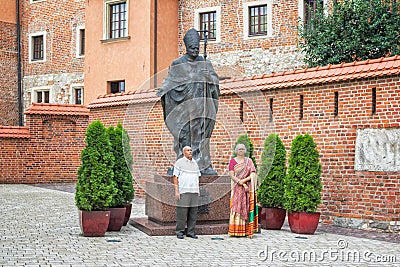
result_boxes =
[88,56,400,108]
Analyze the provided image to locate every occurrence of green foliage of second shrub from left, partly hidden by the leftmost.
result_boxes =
[107,123,135,207]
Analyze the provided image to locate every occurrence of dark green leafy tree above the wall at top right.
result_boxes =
[299,0,400,67]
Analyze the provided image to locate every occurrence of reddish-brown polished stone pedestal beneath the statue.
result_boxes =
[129,175,231,235]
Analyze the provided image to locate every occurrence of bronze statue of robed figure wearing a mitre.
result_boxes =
[157,29,219,175]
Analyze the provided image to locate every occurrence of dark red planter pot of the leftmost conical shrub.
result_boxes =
[79,210,110,236]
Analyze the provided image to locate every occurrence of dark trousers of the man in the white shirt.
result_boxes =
[176,193,199,235]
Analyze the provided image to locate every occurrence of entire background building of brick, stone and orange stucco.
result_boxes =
[0,0,333,120]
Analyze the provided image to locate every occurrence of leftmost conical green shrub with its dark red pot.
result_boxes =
[75,121,117,236]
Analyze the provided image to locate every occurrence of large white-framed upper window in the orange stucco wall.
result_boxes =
[104,0,128,39]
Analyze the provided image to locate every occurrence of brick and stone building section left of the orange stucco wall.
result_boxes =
[19,0,86,112]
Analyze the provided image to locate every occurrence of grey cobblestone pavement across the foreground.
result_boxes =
[0,184,400,266]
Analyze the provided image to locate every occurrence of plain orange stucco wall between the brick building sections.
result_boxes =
[84,0,178,104]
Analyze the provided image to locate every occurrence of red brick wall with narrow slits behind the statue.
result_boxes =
[91,76,400,222]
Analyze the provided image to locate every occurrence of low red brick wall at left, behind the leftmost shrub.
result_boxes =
[0,105,89,184]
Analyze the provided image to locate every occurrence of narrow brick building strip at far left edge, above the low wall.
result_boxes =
[0,21,18,126]
